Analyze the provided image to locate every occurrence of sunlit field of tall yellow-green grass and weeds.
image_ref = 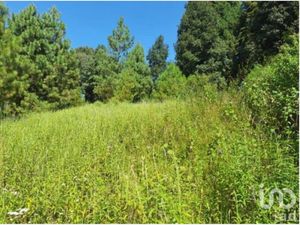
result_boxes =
[0,94,298,223]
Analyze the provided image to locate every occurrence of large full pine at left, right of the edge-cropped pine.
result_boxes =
[9,5,80,108]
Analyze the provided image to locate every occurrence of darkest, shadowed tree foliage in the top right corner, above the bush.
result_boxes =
[234,1,299,79]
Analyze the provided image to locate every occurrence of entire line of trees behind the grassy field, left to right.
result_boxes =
[0,2,299,117]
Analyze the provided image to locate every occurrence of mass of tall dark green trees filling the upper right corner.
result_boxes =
[176,1,299,80]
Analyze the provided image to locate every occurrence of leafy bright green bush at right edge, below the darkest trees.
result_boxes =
[244,35,299,141]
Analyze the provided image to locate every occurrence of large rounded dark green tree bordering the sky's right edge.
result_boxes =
[175,2,240,76]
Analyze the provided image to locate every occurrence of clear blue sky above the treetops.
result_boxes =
[5,1,185,60]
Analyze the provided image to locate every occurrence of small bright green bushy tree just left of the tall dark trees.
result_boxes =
[153,64,186,100]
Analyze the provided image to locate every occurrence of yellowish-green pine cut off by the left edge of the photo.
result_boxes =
[0,3,38,117]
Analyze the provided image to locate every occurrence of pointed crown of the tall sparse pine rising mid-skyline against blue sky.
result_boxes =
[108,17,134,62]
